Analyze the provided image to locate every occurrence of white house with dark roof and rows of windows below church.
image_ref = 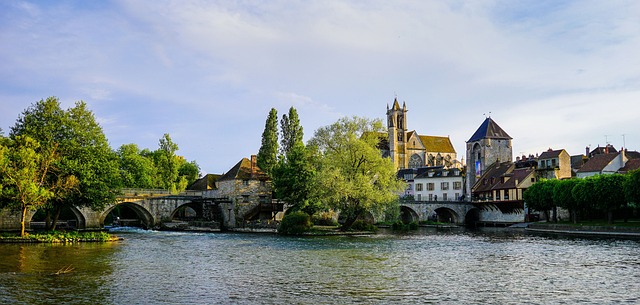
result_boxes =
[413,166,465,201]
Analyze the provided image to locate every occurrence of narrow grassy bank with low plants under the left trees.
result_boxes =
[0,231,120,243]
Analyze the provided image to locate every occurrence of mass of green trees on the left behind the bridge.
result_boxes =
[0,97,200,236]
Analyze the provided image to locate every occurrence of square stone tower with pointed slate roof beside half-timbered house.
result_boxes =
[466,117,513,197]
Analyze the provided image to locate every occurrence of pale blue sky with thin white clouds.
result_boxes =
[0,0,640,174]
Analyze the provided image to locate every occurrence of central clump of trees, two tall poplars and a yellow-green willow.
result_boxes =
[257,107,404,230]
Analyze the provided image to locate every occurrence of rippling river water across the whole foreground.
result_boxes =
[0,228,640,304]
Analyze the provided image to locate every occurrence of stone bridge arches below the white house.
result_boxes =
[400,201,481,225]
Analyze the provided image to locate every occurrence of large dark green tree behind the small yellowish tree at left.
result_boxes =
[10,97,120,229]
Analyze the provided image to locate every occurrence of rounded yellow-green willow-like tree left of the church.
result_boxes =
[309,117,403,230]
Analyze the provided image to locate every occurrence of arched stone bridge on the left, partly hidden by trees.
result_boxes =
[0,190,235,230]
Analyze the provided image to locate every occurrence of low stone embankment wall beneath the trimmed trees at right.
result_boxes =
[524,222,640,239]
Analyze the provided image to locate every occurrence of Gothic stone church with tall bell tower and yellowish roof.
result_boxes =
[380,98,462,170]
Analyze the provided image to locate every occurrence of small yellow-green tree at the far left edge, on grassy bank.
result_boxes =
[0,136,56,236]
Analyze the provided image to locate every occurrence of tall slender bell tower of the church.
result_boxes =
[387,98,407,169]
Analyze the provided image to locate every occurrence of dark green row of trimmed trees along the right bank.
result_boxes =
[523,170,640,224]
